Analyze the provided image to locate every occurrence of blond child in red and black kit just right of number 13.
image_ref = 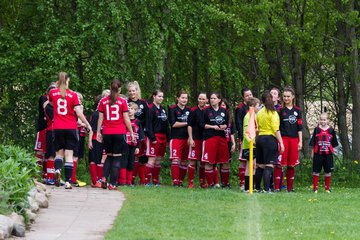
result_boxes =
[119,102,144,186]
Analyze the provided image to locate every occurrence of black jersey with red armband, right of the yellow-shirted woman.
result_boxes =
[279,106,302,137]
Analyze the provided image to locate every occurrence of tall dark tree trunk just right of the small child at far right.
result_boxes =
[335,0,350,158]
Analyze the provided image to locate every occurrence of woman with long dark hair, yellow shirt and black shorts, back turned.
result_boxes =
[255,91,284,192]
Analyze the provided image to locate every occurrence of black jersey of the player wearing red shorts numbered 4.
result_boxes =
[201,107,229,140]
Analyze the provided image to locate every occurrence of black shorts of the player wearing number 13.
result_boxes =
[103,134,128,155]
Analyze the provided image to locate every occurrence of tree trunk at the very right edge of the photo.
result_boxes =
[349,1,360,160]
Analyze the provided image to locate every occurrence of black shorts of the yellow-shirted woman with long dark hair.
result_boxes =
[256,135,279,164]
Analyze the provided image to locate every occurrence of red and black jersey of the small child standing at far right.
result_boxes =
[309,126,339,155]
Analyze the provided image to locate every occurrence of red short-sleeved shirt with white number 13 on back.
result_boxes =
[98,97,129,134]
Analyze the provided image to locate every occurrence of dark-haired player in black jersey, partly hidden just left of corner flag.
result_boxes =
[235,87,253,190]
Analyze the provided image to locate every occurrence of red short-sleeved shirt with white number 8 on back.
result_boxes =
[49,88,80,129]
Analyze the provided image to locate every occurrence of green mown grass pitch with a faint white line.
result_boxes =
[105,186,360,239]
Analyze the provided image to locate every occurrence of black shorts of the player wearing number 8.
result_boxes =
[54,129,79,151]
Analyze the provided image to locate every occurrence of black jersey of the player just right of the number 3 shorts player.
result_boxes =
[169,104,191,139]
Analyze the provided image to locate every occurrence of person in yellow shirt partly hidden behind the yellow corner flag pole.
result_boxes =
[242,97,260,191]
